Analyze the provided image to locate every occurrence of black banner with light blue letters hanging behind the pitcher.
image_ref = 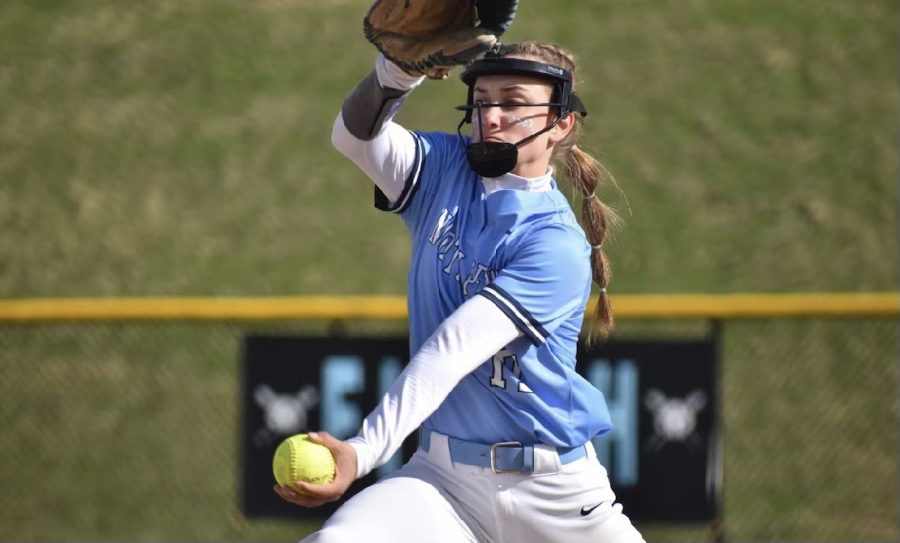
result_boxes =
[242,336,720,522]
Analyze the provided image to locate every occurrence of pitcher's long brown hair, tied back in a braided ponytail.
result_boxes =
[500,42,617,337]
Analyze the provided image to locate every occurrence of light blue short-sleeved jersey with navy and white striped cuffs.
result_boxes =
[375,132,611,447]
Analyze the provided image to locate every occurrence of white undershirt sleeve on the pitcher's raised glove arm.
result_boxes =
[331,55,425,204]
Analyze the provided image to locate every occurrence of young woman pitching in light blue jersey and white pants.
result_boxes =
[275,42,642,543]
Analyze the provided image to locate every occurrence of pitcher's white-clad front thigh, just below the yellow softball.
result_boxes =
[302,476,475,543]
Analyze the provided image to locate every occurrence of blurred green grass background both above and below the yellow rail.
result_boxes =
[0,0,900,541]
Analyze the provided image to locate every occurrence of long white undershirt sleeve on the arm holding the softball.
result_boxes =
[347,296,522,478]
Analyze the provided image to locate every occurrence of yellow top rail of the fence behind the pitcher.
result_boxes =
[0,292,900,323]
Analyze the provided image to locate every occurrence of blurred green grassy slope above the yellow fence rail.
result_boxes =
[0,0,900,297]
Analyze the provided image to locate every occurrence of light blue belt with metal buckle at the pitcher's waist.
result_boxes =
[419,428,587,473]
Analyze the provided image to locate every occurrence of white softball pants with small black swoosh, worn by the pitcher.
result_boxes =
[303,433,644,543]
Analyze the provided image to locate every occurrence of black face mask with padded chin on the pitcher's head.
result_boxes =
[456,56,587,177]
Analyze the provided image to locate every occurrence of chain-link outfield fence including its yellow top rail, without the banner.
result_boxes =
[0,292,900,542]
